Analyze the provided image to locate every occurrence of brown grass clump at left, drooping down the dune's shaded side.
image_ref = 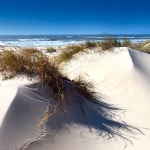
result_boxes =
[0,49,67,123]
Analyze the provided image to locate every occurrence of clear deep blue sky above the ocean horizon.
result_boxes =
[0,0,150,34]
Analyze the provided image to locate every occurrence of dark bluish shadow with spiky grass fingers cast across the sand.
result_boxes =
[27,79,143,147]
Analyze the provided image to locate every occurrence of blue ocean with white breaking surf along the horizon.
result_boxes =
[0,34,150,47]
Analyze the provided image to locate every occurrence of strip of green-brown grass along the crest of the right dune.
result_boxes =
[50,35,150,64]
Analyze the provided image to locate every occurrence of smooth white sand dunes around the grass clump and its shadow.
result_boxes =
[0,47,150,150]
